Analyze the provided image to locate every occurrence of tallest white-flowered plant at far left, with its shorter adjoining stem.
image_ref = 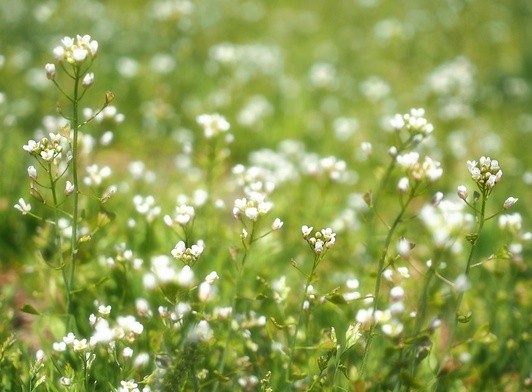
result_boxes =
[15,35,114,330]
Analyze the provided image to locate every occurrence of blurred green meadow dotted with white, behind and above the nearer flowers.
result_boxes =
[0,0,532,266]
